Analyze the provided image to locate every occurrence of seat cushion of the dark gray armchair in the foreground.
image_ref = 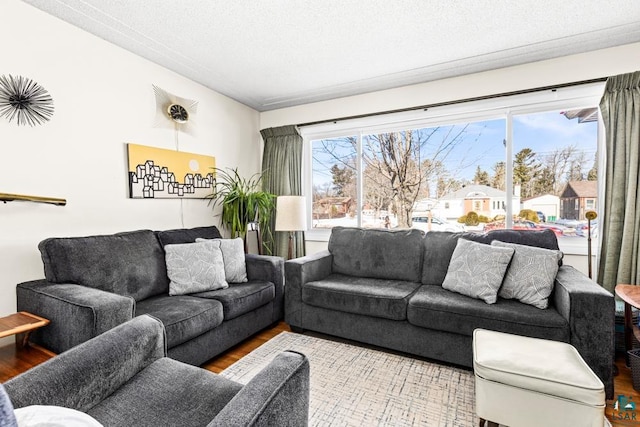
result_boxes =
[87,357,242,427]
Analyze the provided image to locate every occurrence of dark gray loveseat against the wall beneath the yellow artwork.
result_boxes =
[16,226,284,365]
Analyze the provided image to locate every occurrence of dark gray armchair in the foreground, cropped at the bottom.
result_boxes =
[4,316,309,427]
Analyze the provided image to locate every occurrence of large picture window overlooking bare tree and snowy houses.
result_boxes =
[303,85,602,252]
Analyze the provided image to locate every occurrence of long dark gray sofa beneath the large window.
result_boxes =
[285,227,615,397]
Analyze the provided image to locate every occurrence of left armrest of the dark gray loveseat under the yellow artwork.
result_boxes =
[16,280,135,353]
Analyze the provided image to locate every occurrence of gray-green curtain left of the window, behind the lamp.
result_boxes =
[260,125,305,258]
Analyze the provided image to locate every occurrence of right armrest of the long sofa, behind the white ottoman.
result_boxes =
[553,265,615,398]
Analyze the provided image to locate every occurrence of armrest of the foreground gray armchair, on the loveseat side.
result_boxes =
[4,315,166,412]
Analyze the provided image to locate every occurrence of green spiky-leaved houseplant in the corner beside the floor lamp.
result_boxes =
[207,168,276,246]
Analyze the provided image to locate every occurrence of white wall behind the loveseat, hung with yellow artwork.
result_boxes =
[0,0,261,332]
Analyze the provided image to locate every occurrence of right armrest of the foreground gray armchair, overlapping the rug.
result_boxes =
[207,351,309,427]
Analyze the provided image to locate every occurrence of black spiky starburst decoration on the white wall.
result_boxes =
[0,75,53,126]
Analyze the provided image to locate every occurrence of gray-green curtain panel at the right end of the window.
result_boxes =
[598,71,640,292]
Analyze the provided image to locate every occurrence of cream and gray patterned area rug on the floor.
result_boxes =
[221,332,478,427]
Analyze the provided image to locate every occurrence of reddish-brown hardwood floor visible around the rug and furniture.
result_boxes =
[0,322,640,427]
